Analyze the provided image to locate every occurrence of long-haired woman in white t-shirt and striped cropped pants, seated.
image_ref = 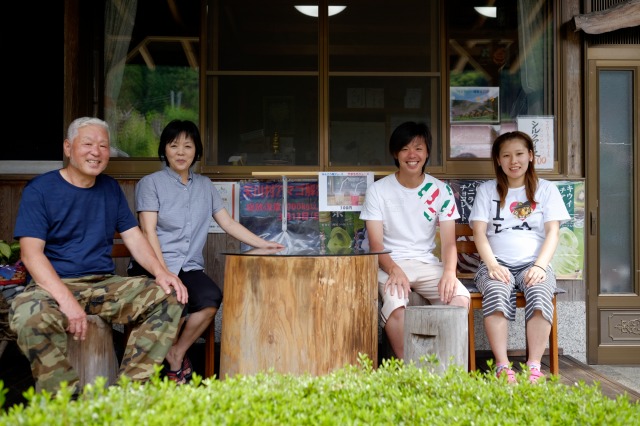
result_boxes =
[469,131,570,383]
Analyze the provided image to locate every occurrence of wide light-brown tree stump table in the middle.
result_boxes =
[220,250,378,379]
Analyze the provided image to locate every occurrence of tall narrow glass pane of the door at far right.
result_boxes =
[598,71,636,294]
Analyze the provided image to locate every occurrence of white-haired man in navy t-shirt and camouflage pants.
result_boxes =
[9,117,187,393]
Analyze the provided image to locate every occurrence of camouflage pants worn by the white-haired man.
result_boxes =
[9,275,183,393]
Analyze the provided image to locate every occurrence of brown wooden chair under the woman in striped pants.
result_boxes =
[456,223,565,375]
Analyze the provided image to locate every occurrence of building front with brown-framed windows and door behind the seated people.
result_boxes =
[0,0,640,364]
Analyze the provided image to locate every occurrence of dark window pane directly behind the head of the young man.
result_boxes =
[328,0,442,167]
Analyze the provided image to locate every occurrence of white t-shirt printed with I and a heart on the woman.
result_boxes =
[469,179,570,266]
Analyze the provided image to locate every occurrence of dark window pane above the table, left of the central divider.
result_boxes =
[205,0,320,171]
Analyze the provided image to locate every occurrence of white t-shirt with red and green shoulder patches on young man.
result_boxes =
[360,174,460,263]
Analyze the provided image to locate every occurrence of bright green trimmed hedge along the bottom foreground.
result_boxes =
[0,356,640,426]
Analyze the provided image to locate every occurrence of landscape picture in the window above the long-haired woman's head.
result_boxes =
[449,87,500,124]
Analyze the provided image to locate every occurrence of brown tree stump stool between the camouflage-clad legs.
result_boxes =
[67,315,118,389]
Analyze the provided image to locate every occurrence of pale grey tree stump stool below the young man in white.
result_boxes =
[404,305,469,373]
